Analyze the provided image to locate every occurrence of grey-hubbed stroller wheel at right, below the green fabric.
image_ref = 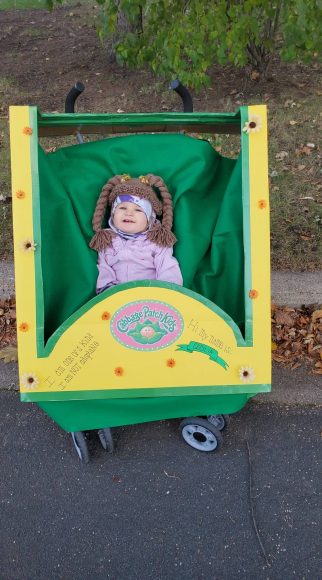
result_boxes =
[179,417,223,452]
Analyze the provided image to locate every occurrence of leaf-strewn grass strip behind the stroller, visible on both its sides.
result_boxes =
[0,95,322,271]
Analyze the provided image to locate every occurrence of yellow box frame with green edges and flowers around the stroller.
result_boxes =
[10,106,271,401]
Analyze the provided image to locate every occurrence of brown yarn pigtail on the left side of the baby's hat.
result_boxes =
[89,175,123,252]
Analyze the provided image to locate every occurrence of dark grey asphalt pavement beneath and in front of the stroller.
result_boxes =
[0,392,322,580]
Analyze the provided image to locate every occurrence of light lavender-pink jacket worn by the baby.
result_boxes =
[96,236,183,293]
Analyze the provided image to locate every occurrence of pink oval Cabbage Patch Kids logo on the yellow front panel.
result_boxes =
[111,300,183,351]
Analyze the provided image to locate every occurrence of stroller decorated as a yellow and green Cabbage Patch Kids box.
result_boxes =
[10,82,271,462]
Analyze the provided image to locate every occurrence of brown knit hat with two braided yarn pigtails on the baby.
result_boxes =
[89,173,177,252]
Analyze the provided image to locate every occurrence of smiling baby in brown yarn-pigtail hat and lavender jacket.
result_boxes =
[90,174,183,293]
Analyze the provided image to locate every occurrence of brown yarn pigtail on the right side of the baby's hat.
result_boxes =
[146,173,177,248]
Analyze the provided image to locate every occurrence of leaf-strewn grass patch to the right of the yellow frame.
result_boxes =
[269,96,322,270]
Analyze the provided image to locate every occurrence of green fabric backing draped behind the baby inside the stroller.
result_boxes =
[39,134,245,341]
